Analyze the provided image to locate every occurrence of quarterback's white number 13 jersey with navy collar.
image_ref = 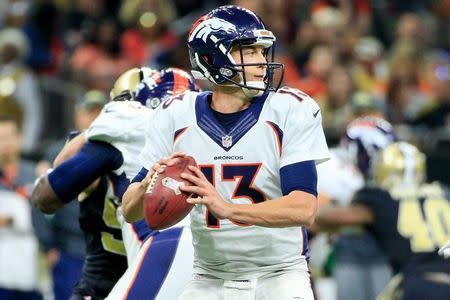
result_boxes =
[141,88,328,279]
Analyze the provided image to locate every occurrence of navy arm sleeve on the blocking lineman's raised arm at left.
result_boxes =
[48,142,123,203]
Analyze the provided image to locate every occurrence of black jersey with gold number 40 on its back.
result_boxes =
[353,183,450,272]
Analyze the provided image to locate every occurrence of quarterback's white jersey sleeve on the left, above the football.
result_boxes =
[139,105,174,170]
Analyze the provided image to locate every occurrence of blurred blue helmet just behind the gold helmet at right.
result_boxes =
[340,116,397,177]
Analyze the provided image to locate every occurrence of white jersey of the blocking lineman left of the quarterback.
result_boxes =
[85,101,153,265]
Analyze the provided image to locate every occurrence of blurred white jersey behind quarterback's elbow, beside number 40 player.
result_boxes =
[317,148,364,206]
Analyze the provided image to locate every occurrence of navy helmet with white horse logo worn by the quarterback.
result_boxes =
[188,5,284,95]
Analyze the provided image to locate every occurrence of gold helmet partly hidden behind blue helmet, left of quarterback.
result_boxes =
[109,67,157,101]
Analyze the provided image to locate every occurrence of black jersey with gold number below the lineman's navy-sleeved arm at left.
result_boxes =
[75,176,127,298]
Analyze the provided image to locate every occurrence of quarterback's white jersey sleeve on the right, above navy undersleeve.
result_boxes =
[280,95,329,167]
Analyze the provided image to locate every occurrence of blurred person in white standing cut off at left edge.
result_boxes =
[0,116,42,300]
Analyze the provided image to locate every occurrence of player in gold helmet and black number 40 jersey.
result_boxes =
[316,142,450,300]
